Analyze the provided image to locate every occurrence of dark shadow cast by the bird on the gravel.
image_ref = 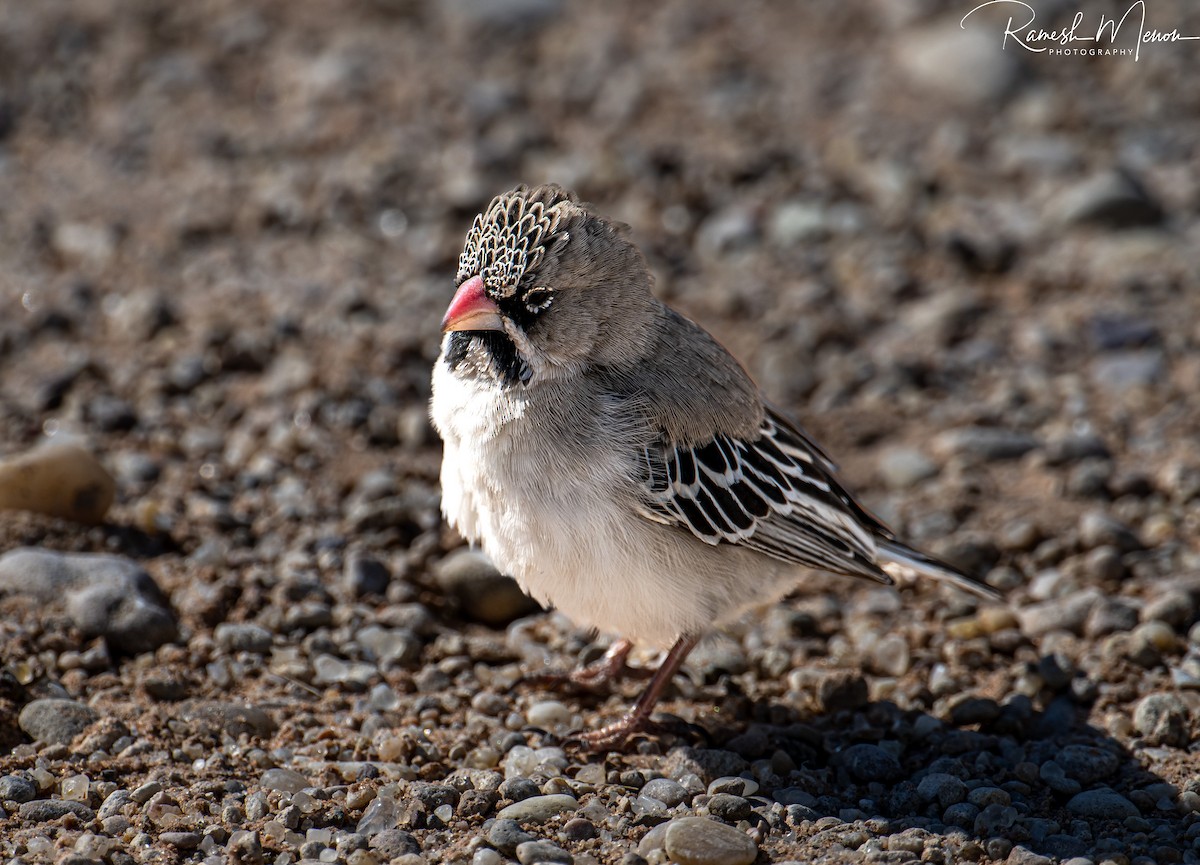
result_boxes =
[537,693,1192,861]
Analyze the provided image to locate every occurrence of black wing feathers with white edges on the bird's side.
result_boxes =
[642,410,892,583]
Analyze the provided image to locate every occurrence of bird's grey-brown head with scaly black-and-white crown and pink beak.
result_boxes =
[443,186,658,383]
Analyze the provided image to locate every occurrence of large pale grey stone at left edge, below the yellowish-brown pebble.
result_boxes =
[0,547,179,654]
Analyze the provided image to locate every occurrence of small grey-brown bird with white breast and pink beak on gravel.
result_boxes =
[431,185,995,750]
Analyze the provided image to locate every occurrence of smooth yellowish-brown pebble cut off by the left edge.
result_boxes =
[0,444,116,524]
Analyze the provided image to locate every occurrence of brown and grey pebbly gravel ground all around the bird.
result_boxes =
[0,0,1200,865]
